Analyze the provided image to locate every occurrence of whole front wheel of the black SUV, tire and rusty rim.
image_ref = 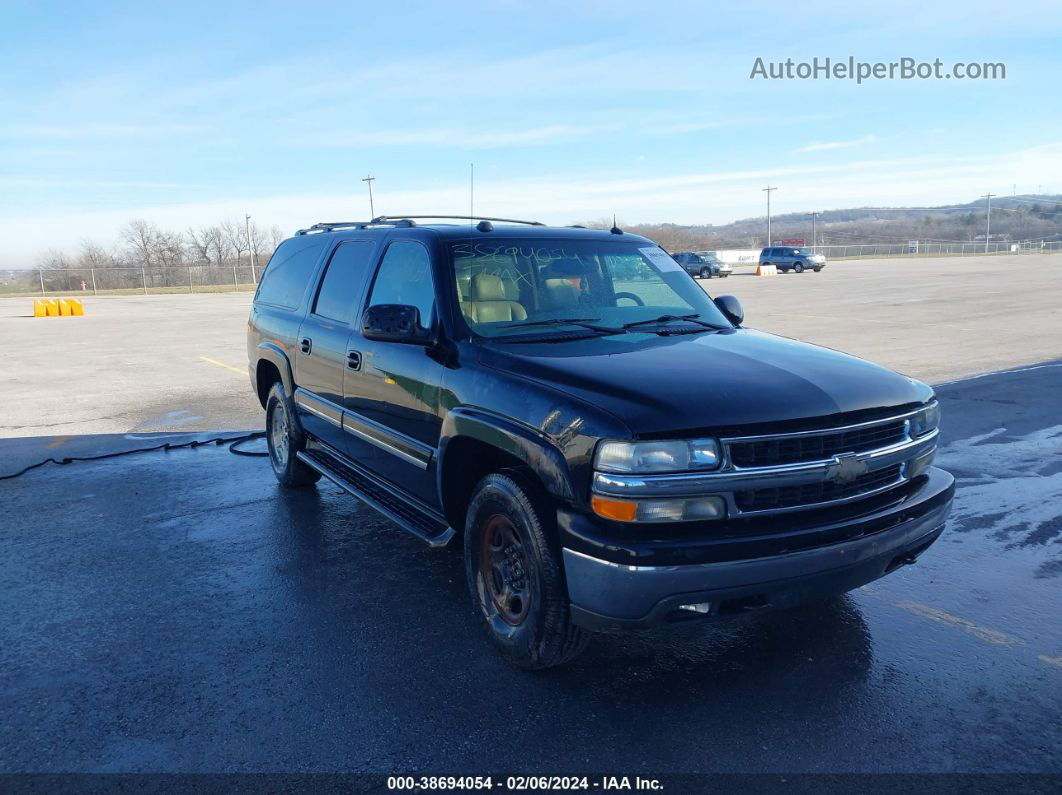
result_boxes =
[464,472,589,670]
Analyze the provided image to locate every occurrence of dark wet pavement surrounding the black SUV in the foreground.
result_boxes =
[0,364,1062,774]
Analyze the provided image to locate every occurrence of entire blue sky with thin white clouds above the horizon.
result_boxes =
[0,0,1062,267]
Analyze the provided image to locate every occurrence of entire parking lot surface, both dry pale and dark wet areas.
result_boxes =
[0,257,1062,774]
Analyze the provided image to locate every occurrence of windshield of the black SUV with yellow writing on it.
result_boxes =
[450,239,731,336]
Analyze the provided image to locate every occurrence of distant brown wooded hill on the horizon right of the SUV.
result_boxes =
[588,194,1062,250]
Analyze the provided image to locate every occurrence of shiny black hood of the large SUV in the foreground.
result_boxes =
[479,329,932,435]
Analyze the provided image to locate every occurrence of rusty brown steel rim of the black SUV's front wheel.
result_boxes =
[479,514,531,626]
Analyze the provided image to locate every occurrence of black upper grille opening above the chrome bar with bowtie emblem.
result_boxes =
[730,419,906,467]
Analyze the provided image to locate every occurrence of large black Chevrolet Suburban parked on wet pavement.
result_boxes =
[247,217,954,668]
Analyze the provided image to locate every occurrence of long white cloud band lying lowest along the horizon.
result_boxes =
[0,141,1062,267]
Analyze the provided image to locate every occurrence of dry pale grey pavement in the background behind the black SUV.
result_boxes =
[0,255,1062,437]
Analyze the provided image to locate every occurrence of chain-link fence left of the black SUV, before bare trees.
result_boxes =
[0,265,261,297]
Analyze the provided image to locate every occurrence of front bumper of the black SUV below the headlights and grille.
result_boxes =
[563,467,955,629]
